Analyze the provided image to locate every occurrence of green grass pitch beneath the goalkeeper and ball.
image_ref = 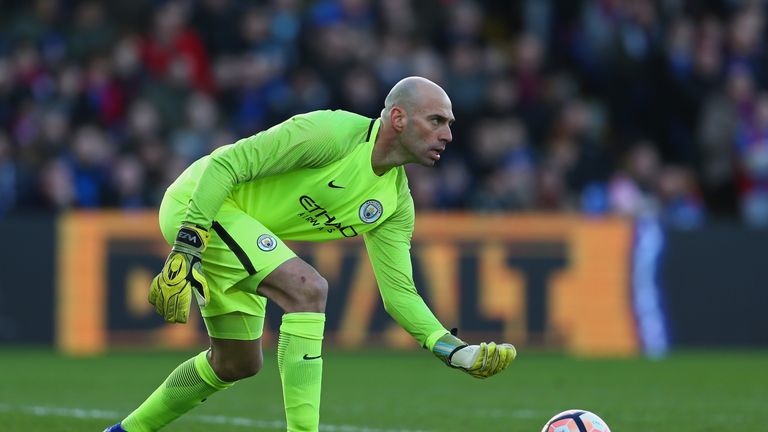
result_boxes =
[0,348,768,432]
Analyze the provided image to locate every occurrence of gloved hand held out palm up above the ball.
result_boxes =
[432,330,517,378]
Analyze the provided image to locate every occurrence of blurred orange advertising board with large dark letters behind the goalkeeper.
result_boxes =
[56,212,639,356]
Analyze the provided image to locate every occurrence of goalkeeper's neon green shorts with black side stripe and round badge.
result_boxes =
[159,193,296,340]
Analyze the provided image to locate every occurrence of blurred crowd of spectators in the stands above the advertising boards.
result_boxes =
[0,0,768,227]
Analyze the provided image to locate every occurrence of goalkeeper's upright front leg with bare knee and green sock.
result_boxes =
[258,258,328,432]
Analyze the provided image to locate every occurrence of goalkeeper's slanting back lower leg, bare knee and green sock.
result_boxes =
[121,330,262,432]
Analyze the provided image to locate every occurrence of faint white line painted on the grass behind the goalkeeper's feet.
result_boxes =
[0,403,427,432]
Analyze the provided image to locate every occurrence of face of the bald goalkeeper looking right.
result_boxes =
[402,94,454,166]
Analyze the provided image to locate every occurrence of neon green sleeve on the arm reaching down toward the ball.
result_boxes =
[363,172,448,349]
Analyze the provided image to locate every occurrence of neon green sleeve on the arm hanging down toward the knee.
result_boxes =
[185,111,345,228]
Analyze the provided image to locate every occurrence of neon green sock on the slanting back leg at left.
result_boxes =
[122,351,234,432]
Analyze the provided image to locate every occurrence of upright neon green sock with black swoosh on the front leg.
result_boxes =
[278,312,325,432]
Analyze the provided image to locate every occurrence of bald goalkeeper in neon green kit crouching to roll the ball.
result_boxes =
[107,77,516,432]
